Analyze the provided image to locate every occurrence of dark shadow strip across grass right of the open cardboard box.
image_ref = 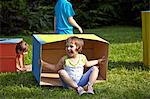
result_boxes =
[108,61,150,71]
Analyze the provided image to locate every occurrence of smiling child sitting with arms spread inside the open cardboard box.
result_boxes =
[41,36,105,95]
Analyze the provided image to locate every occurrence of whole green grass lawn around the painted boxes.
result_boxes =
[0,26,150,99]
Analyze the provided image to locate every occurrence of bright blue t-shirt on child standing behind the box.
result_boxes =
[55,0,75,34]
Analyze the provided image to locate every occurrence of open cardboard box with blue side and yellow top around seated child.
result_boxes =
[32,34,109,86]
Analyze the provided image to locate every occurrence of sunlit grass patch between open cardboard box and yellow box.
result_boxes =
[109,42,143,62]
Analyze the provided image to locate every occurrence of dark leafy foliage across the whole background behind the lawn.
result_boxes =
[0,0,150,35]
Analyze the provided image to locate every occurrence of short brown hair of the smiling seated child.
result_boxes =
[66,36,84,52]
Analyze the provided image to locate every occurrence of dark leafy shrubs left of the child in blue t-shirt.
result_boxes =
[0,0,53,35]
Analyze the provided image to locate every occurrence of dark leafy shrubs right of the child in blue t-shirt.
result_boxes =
[73,0,150,28]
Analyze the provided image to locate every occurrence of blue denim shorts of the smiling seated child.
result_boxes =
[60,67,93,88]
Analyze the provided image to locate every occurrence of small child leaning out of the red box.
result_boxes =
[16,41,28,71]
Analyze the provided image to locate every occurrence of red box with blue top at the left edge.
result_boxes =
[0,38,23,72]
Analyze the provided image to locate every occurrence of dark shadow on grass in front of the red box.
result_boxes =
[0,72,36,87]
